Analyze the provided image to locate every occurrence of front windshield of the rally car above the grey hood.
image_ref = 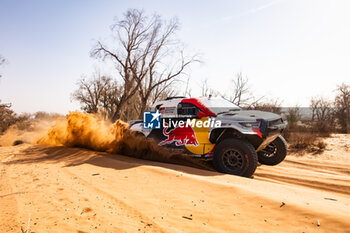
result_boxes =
[201,98,241,114]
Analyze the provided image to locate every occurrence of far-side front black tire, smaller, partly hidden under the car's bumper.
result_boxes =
[258,135,287,166]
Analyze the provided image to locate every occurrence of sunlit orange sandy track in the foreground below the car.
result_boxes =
[0,145,350,232]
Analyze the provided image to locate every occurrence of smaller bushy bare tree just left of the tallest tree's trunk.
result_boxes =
[72,71,121,118]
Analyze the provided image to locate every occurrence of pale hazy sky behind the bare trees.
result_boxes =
[0,0,350,113]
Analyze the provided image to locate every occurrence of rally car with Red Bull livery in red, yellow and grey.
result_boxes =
[130,97,287,177]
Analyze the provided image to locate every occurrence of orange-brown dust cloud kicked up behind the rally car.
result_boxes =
[0,111,211,170]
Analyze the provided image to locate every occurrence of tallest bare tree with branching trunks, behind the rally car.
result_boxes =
[91,9,196,120]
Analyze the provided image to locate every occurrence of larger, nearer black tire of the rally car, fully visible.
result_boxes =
[213,138,258,177]
